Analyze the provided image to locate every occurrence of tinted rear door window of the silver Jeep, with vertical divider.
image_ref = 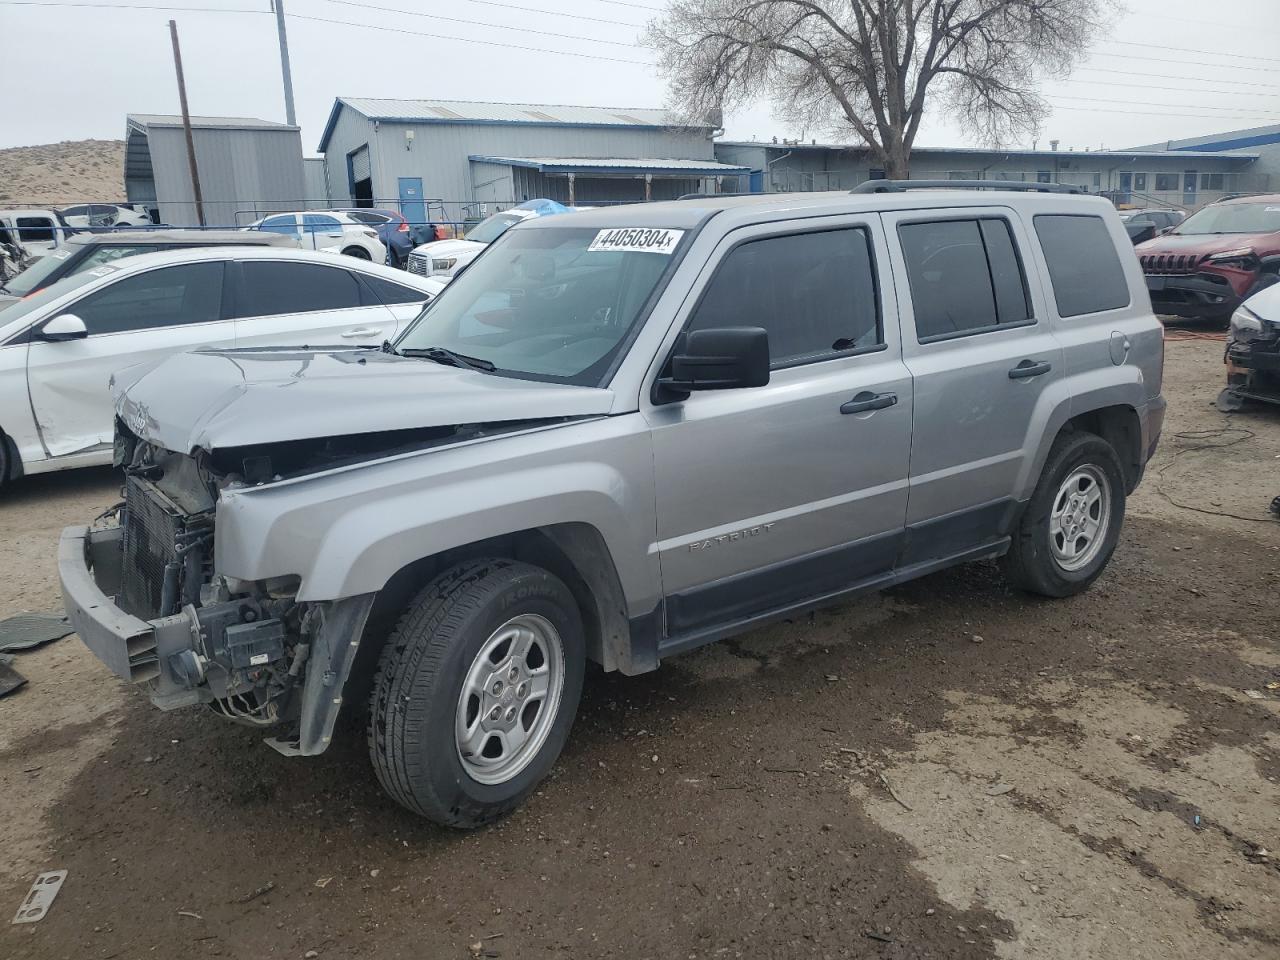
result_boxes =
[899,218,1032,342]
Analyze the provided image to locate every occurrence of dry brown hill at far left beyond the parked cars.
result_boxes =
[0,140,124,206]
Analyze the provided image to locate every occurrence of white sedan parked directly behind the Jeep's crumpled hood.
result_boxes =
[0,247,444,485]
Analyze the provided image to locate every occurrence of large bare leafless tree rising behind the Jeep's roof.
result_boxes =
[645,0,1115,178]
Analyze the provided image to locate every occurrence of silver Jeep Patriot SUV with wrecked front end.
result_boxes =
[59,182,1165,827]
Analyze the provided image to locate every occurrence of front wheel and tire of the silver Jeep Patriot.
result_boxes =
[369,559,586,828]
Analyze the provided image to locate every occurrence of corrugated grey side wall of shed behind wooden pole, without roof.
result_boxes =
[147,127,306,227]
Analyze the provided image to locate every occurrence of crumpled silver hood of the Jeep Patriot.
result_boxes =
[111,347,613,453]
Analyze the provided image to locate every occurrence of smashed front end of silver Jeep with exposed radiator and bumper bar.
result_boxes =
[59,426,374,755]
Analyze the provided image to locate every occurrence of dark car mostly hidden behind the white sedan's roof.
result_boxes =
[0,229,297,308]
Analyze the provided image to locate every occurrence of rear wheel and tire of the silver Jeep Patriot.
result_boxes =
[1001,430,1125,596]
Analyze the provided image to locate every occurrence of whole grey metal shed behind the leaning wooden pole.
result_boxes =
[124,114,307,227]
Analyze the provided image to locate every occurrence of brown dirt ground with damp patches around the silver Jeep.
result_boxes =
[0,339,1280,960]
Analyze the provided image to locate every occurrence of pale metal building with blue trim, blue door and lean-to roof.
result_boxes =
[320,97,748,220]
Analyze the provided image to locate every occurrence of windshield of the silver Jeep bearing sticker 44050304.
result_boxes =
[396,227,684,387]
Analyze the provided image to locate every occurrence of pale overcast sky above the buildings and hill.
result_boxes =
[0,0,1280,155]
